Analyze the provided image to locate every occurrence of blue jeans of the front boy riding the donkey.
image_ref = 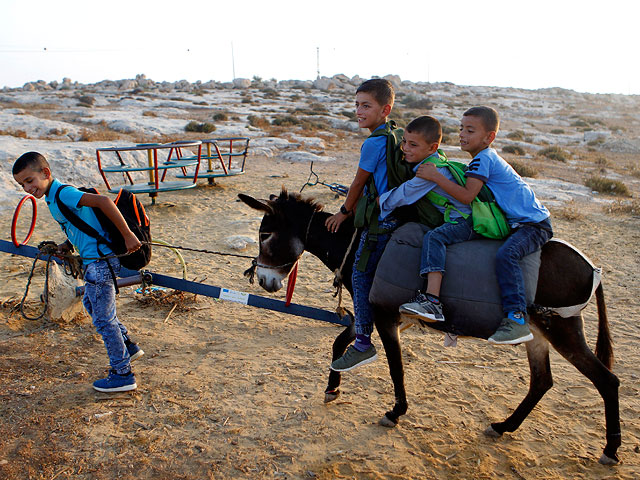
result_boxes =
[351,216,398,335]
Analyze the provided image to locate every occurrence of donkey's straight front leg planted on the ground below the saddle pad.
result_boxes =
[373,305,408,427]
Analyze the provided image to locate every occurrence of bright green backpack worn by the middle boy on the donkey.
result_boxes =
[423,150,511,240]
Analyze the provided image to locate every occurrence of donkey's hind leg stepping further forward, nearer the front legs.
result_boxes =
[484,325,553,437]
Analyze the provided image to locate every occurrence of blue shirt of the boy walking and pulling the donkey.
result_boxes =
[45,179,113,265]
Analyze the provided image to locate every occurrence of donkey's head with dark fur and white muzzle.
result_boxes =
[238,188,322,292]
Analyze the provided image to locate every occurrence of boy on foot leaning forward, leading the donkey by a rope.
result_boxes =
[13,152,144,392]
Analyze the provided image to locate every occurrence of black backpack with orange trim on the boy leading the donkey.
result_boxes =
[56,185,151,270]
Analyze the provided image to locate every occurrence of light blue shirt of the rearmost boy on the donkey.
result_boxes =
[465,147,549,226]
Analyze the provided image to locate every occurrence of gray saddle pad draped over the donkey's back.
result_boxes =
[369,223,540,338]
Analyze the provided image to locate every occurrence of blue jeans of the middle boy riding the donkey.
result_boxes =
[420,217,481,278]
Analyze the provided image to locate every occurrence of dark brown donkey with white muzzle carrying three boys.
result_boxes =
[238,188,621,465]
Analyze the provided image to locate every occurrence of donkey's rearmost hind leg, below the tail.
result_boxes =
[547,315,621,465]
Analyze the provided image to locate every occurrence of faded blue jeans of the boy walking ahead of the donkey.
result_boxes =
[82,258,131,374]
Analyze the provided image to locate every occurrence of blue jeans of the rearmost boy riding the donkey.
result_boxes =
[496,219,553,315]
